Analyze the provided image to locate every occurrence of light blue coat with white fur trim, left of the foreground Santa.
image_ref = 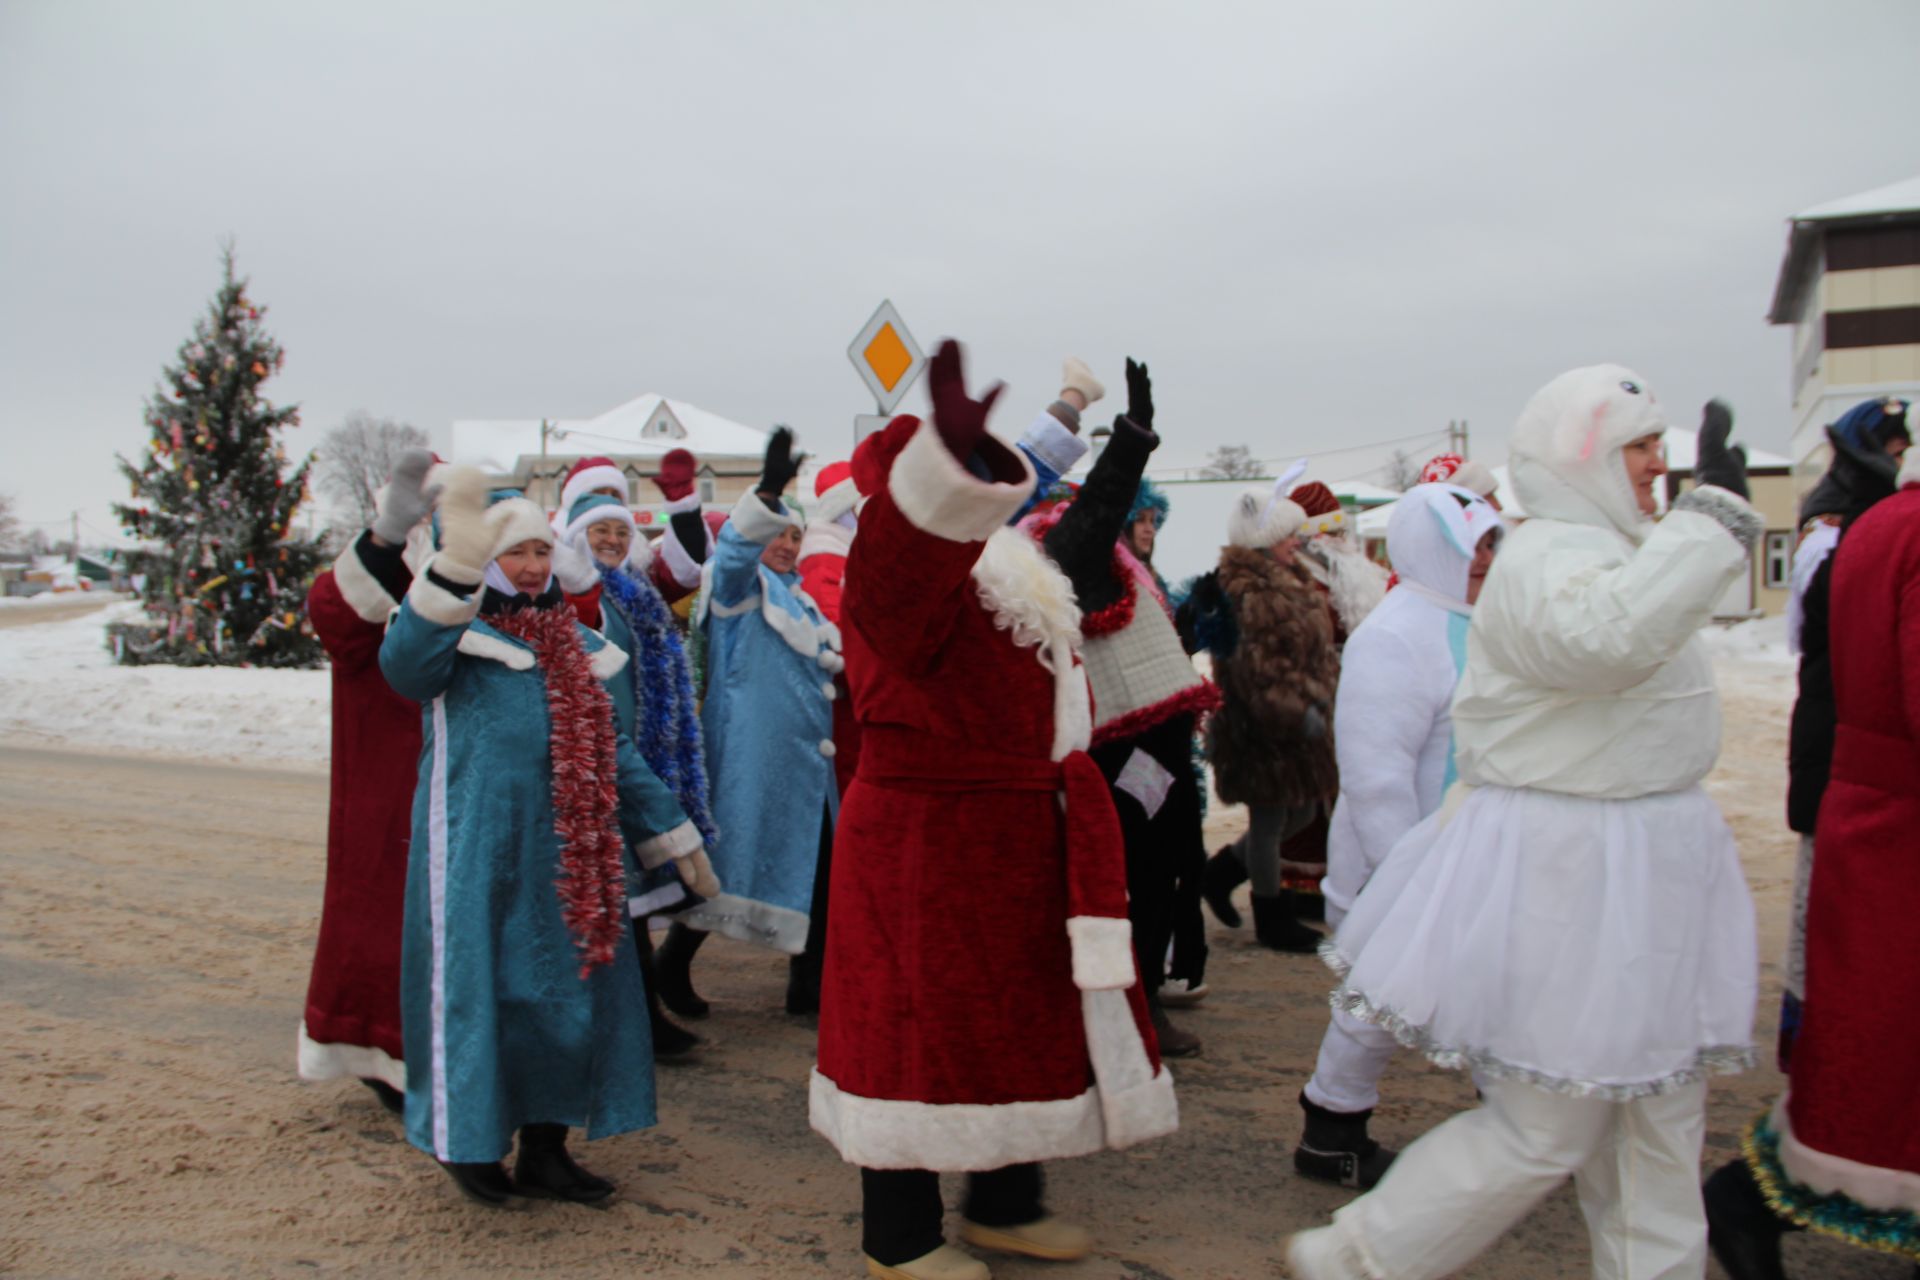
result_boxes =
[682,493,845,956]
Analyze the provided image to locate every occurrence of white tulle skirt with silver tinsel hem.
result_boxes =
[1321,787,1759,1102]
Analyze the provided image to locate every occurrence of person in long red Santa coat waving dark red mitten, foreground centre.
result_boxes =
[810,342,1179,1280]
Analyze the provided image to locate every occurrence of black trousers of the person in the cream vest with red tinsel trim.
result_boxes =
[1089,716,1206,996]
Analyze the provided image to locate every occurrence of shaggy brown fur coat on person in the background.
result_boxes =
[1206,547,1340,806]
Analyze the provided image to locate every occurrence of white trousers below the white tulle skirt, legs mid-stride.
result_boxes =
[1308,1079,1707,1280]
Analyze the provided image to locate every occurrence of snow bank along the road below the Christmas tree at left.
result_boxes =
[0,595,332,764]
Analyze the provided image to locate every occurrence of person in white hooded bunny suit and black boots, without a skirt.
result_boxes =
[1294,484,1505,1188]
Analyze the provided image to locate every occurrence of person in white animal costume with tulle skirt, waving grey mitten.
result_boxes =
[1286,365,1763,1280]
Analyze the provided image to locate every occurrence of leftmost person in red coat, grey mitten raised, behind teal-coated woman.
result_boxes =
[300,449,434,1115]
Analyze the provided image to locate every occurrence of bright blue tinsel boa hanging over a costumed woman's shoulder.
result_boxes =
[601,566,716,846]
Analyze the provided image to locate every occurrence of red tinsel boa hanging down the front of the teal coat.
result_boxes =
[486,608,626,977]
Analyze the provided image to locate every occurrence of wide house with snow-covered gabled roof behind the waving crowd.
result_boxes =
[449,393,772,528]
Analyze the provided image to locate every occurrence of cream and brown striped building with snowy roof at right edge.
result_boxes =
[1766,177,1920,489]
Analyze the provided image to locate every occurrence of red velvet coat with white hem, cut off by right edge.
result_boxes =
[1780,486,1920,1213]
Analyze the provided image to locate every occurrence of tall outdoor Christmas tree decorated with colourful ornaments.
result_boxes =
[108,249,323,666]
